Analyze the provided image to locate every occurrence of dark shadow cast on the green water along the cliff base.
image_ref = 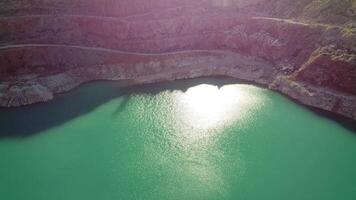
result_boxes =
[0,77,356,138]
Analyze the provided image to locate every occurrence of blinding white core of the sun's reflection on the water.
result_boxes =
[178,84,258,130]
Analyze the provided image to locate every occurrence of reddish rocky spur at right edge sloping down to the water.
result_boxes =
[270,46,356,119]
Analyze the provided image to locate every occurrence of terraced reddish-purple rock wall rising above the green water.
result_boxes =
[0,0,356,119]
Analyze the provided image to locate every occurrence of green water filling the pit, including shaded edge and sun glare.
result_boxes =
[0,78,356,200]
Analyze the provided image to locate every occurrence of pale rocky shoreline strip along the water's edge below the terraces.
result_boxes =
[0,52,356,120]
